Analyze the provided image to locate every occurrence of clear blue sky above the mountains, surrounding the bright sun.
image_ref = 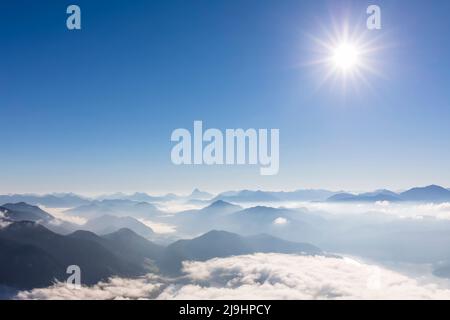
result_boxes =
[0,0,450,194]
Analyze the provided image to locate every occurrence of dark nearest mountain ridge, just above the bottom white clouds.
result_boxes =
[0,221,321,289]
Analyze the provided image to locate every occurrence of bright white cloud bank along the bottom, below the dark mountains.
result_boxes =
[14,254,450,299]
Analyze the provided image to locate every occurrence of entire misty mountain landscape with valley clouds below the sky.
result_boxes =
[0,185,450,299]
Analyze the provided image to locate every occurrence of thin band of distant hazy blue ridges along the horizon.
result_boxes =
[0,185,450,204]
